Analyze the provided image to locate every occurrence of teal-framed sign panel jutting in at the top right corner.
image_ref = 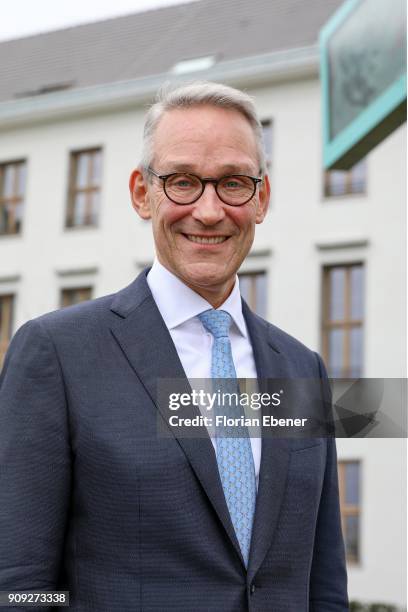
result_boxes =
[320,0,407,170]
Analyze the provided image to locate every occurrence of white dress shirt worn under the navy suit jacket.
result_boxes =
[147,259,261,486]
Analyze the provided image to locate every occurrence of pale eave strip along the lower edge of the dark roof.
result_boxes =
[0,44,319,129]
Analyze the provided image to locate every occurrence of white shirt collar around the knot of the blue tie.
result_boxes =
[147,258,248,337]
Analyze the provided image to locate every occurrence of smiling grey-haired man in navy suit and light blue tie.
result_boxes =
[0,83,348,612]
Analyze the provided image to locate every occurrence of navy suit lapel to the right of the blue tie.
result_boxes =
[243,302,290,581]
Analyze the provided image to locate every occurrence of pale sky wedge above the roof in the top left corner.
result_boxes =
[0,0,198,40]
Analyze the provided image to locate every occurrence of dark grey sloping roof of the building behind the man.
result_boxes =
[0,0,343,101]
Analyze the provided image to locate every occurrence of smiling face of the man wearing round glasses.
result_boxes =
[131,105,269,303]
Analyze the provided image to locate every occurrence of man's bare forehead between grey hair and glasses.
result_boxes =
[153,105,258,166]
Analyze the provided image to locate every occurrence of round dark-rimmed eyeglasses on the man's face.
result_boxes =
[147,167,262,206]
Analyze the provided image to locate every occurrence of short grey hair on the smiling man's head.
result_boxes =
[141,81,266,174]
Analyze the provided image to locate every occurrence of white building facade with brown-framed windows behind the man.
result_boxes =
[0,3,406,609]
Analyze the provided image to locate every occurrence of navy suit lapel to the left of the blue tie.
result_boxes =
[111,271,243,562]
